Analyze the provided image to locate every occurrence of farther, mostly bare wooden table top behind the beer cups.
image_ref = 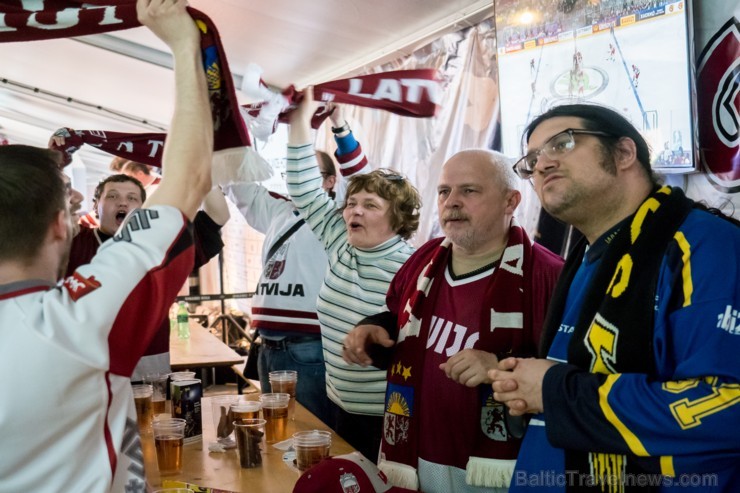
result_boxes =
[170,320,244,371]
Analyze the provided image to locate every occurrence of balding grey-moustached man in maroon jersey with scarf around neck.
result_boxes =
[344,150,562,493]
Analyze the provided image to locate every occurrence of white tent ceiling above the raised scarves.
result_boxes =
[0,0,493,181]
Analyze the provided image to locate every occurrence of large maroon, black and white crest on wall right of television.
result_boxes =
[697,18,740,193]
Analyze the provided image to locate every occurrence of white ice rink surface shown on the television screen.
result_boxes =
[499,9,691,167]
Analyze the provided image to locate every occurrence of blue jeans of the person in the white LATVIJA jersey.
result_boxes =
[257,338,330,424]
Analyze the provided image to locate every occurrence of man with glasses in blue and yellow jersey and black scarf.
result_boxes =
[489,104,740,492]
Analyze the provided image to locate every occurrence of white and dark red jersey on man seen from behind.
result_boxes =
[0,206,193,492]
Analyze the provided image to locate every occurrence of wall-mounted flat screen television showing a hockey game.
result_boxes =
[494,0,698,173]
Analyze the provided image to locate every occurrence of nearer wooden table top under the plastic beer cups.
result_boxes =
[141,397,354,493]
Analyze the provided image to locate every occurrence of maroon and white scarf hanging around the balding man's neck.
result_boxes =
[379,225,536,488]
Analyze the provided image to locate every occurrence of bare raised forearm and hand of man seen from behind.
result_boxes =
[136,0,213,219]
